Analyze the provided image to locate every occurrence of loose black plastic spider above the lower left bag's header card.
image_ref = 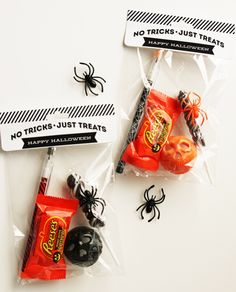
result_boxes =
[73,63,106,96]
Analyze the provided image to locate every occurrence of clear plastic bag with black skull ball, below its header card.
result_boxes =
[5,144,121,284]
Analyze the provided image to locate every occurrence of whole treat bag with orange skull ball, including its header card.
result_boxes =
[116,10,235,184]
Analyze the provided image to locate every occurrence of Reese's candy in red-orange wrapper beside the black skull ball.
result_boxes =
[20,194,78,280]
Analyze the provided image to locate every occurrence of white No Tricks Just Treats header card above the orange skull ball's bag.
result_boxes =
[125,10,235,58]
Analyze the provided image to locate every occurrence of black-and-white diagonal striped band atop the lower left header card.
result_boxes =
[0,104,115,125]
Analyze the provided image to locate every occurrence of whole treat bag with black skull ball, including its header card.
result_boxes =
[0,88,122,284]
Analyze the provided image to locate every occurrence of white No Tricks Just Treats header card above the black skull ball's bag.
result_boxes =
[0,103,116,151]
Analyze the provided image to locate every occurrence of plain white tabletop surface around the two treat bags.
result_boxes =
[0,0,236,292]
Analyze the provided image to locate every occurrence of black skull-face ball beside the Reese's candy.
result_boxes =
[64,226,102,267]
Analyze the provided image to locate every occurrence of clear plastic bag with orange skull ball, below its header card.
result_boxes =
[116,48,227,183]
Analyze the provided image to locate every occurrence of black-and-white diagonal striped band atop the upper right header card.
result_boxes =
[127,10,235,34]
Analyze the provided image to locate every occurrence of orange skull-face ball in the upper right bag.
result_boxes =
[160,136,197,174]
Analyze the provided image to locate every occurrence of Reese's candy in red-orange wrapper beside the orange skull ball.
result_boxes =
[121,90,181,172]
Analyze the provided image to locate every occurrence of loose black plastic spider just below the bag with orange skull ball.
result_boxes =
[136,185,165,222]
